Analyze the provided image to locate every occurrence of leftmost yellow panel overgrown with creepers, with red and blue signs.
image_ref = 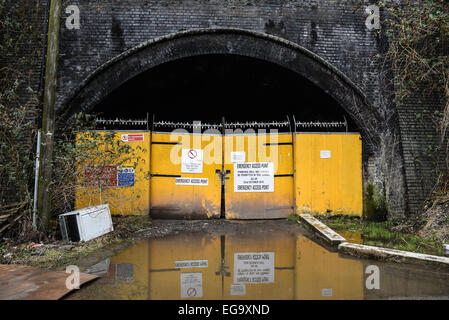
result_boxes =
[75,132,150,215]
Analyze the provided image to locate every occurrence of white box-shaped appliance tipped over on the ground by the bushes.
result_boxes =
[59,204,114,241]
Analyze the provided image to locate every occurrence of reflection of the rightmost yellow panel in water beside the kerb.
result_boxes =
[294,235,364,300]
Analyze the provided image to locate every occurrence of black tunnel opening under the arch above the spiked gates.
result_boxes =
[94,55,358,132]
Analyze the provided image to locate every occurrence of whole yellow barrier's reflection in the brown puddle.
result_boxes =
[98,230,365,300]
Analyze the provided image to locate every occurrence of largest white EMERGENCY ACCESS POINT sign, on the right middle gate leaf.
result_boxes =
[234,162,274,192]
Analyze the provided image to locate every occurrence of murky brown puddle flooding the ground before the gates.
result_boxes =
[68,224,449,300]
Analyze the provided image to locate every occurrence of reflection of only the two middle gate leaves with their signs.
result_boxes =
[147,232,299,300]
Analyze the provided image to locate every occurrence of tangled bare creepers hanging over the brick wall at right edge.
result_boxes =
[378,0,449,204]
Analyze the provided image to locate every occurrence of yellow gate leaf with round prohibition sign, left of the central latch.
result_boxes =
[150,133,222,219]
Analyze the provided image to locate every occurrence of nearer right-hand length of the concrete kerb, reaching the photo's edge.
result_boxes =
[338,243,449,269]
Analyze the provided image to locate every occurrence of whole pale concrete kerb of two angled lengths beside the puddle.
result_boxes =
[298,214,449,269]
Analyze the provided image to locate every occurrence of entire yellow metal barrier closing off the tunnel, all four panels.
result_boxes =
[75,127,363,219]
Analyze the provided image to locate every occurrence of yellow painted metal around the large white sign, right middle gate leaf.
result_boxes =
[224,134,294,219]
